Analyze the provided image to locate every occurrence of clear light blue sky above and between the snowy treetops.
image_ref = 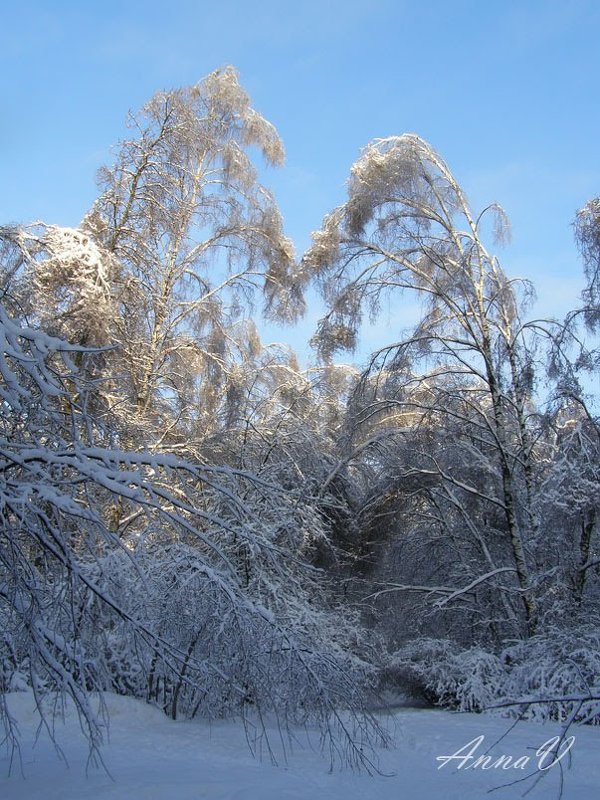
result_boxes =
[0,0,600,362]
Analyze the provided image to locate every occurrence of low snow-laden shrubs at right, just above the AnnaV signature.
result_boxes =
[390,623,600,724]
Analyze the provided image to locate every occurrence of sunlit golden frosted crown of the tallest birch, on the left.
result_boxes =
[25,67,302,445]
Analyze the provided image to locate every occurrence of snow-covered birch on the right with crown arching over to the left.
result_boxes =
[302,135,538,635]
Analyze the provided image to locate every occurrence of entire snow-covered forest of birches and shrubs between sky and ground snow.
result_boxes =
[0,67,600,792]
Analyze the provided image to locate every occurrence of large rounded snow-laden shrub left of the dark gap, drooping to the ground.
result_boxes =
[88,544,376,723]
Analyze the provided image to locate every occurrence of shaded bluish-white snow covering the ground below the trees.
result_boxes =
[0,693,600,800]
